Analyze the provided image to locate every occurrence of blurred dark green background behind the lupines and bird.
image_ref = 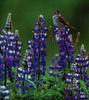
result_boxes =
[0,0,89,65]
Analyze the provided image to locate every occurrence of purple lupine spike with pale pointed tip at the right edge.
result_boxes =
[75,45,89,81]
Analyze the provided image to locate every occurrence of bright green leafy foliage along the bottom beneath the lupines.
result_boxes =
[10,76,65,100]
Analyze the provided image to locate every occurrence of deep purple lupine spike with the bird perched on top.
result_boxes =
[53,16,74,71]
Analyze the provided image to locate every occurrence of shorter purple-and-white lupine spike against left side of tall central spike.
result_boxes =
[22,44,36,80]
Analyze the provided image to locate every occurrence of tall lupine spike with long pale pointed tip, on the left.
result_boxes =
[3,13,15,86]
